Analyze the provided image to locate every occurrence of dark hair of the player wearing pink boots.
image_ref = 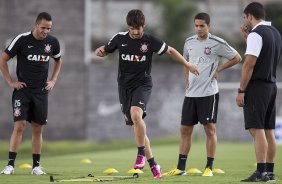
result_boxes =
[126,9,145,28]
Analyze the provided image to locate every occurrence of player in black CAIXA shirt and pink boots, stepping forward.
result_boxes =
[95,9,198,179]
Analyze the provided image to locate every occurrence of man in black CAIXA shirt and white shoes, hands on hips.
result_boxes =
[0,12,61,175]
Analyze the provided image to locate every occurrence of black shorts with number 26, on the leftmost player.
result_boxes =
[12,89,48,125]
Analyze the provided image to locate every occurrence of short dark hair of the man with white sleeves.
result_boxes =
[244,2,265,20]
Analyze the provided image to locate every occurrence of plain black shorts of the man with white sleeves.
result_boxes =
[244,81,277,129]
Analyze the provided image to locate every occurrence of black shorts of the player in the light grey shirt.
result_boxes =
[181,93,219,126]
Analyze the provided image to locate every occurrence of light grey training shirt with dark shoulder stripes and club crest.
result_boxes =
[183,33,237,97]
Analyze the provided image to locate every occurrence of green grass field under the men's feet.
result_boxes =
[0,141,282,184]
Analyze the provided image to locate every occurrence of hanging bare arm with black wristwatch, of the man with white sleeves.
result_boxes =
[236,55,257,107]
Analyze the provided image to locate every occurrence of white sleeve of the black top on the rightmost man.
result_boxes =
[245,32,262,57]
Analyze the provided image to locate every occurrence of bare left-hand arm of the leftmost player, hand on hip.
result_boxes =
[0,52,26,90]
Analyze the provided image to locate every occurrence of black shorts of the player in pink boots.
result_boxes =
[118,85,152,125]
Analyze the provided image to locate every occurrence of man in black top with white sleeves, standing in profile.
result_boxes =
[236,2,282,182]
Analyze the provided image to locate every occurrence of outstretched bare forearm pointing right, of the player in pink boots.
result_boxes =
[166,46,199,75]
